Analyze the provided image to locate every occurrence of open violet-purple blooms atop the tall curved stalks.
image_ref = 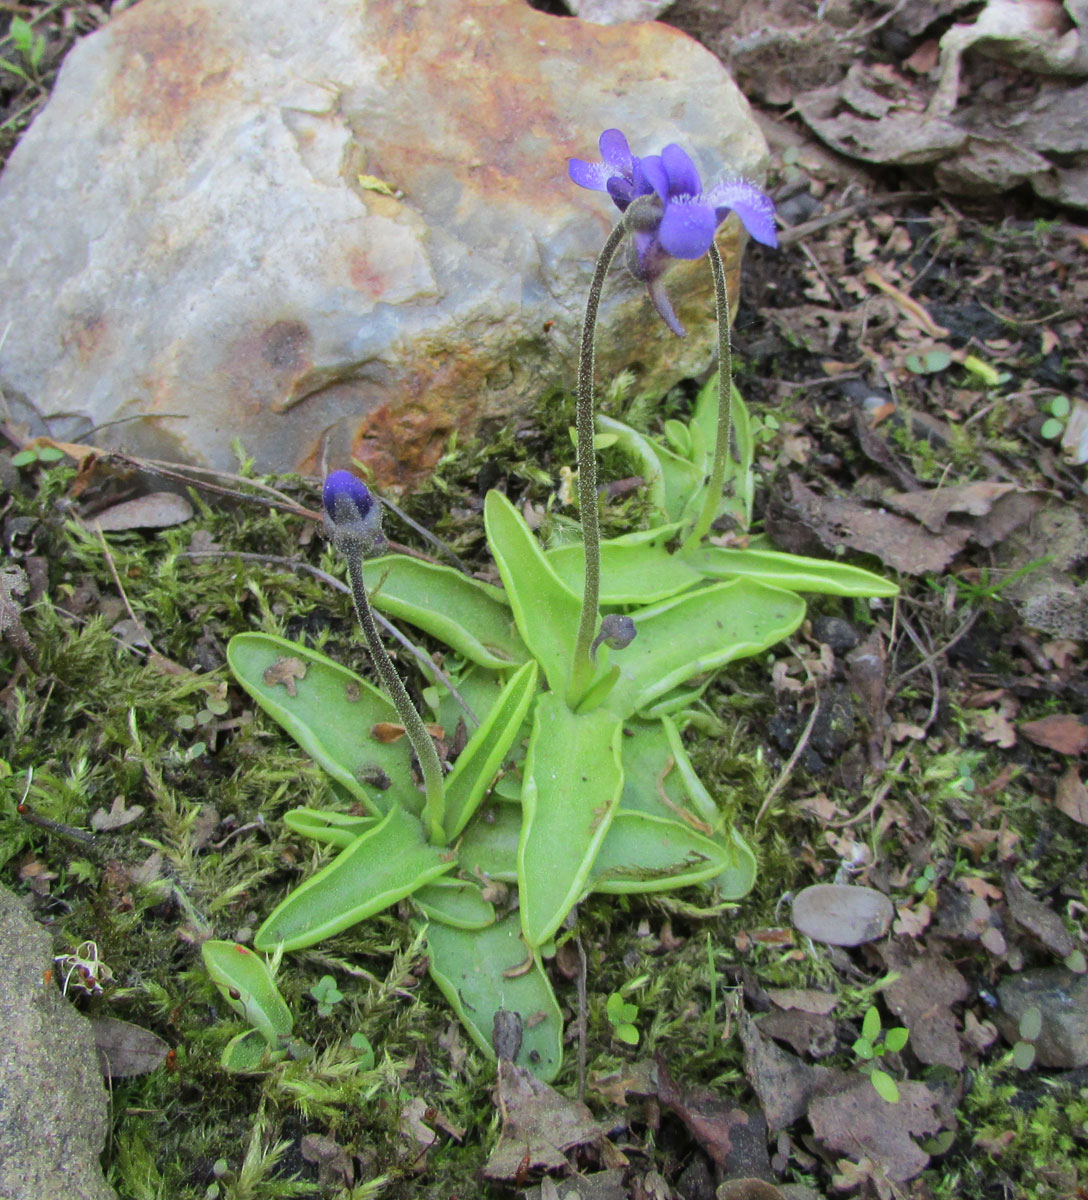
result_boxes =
[567,130,779,337]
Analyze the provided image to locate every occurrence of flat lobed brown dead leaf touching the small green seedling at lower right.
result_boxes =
[809,1075,940,1183]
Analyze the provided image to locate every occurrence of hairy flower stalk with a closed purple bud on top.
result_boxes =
[323,470,447,846]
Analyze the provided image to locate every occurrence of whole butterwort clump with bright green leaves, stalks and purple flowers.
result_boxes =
[214,131,894,1079]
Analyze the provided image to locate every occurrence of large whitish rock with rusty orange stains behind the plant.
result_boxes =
[0,0,765,482]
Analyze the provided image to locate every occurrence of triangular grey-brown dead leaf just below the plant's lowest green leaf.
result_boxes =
[483,1060,603,1180]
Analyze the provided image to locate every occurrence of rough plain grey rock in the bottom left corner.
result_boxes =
[0,888,116,1200]
